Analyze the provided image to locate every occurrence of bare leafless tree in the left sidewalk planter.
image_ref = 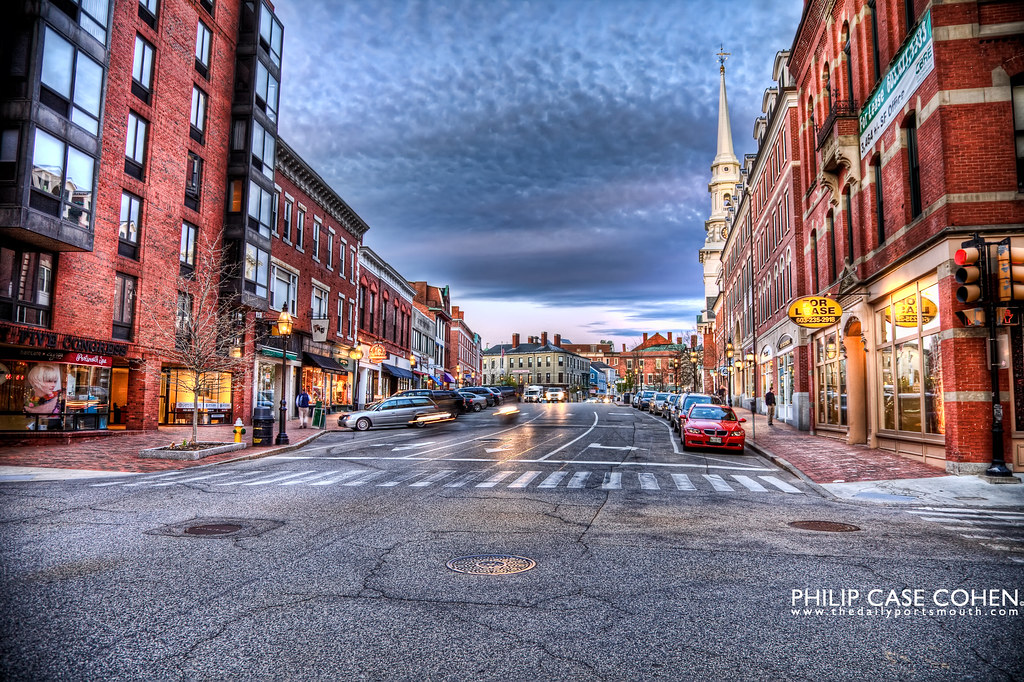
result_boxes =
[141,233,252,444]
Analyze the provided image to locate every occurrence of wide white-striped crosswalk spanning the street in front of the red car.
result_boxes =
[90,467,804,495]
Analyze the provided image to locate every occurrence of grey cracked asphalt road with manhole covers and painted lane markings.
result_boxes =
[0,403,1024,680]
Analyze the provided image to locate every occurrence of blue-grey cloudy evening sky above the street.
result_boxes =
[275,0,803,346]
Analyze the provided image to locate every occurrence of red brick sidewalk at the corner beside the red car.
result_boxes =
[735,408,948,483]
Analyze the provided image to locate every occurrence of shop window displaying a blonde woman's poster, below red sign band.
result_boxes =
[0,360,111,431]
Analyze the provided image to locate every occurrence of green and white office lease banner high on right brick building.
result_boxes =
[860,10,935,159]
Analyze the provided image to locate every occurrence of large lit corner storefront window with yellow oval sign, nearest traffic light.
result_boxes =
[879,283,945,434]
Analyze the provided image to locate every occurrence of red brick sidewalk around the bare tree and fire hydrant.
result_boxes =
[0,420,330,473]
